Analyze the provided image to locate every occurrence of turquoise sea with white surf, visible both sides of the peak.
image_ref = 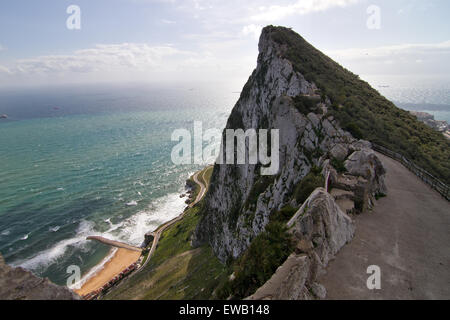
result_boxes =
[0,76,450,285]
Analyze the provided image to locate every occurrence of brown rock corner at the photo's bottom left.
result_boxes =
[0,255,80,300]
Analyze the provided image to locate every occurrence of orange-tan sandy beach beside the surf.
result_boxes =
[75,248,141,296]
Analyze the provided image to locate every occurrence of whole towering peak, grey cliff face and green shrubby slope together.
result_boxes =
[193,26,450,262]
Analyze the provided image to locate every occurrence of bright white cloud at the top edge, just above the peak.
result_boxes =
[250,0,359,22]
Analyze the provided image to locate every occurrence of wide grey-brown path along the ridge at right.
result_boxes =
[319,154,450,299]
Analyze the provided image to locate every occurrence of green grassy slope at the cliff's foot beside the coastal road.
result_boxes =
[104,168,229,300]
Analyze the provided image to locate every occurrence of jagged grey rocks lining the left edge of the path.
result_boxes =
[247,140,386,300]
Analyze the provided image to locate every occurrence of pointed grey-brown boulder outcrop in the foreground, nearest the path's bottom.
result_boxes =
[248,188,355,300]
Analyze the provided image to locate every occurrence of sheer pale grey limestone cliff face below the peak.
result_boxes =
[193,27,384,262]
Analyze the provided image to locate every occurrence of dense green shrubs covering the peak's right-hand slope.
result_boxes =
[263,26,450,184]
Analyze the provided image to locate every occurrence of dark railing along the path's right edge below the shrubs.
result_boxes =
[372,143,450,201]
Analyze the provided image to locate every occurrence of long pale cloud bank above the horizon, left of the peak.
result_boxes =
[0,42,254,85]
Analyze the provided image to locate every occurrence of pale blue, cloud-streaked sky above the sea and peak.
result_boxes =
[0,0,450,87]
